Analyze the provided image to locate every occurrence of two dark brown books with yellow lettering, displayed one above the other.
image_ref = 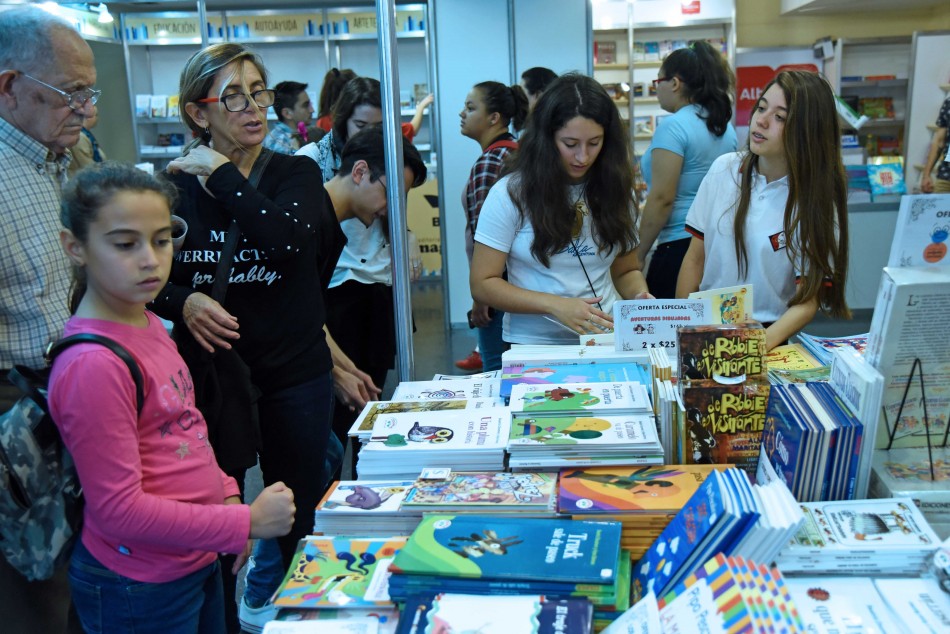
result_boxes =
[674,322,769,476]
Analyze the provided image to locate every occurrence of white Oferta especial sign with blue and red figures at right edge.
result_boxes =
[887,194,950,267]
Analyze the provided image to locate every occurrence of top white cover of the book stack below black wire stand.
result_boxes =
[782,498,940,556]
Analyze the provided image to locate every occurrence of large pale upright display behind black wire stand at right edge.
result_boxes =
[866,267,950,448]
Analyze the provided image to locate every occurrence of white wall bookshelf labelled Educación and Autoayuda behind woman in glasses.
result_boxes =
[117,4,434,169]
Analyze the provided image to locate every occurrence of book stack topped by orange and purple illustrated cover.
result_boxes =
[557,465,727,561]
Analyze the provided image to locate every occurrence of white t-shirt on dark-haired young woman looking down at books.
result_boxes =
[475,176,620,344]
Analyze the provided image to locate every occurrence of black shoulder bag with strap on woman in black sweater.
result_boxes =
[172,150,272,473]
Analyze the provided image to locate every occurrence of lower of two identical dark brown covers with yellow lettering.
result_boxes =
[676,380,769,477]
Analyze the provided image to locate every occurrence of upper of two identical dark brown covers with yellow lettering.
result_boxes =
[677,322,766,386]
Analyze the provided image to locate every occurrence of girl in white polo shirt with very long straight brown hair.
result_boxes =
[676,71,850,349]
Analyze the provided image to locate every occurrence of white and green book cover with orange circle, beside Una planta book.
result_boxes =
[508,413,660,451]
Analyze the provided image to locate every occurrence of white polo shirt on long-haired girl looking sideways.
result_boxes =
[686,153,798,322]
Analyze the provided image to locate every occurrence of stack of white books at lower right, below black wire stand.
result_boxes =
[775,498,940,576]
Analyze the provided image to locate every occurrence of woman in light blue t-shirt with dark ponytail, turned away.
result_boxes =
[637,40,737,299]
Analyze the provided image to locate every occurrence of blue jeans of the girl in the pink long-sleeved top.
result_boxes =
[69,541,225,634]
